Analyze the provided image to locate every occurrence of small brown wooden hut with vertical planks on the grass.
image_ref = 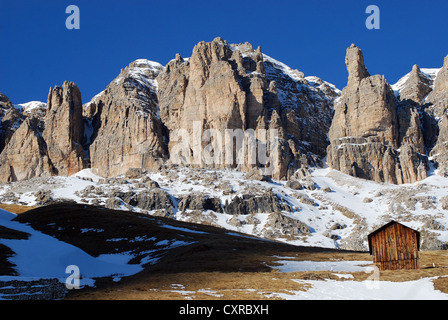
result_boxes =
[368,221,420,270]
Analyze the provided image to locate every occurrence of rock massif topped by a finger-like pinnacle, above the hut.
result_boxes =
[327,45,428,184]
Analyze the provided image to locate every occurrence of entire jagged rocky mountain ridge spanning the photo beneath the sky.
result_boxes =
[0,37,448,184]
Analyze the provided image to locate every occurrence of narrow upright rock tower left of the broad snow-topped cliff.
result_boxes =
[42,81,87,175]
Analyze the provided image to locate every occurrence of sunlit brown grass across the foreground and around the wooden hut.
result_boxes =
[68,251,448,300]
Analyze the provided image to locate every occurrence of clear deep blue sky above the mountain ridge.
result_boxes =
[0,0,448,103]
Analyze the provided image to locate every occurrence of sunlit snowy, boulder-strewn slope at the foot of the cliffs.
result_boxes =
[0,162,448,250]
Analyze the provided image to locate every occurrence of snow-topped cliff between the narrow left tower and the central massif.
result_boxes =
[86,59,167,177]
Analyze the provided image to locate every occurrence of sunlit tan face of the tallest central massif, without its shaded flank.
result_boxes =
[157,38,267,176]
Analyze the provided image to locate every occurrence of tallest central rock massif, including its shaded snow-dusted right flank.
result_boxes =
[157,38,338,179]
